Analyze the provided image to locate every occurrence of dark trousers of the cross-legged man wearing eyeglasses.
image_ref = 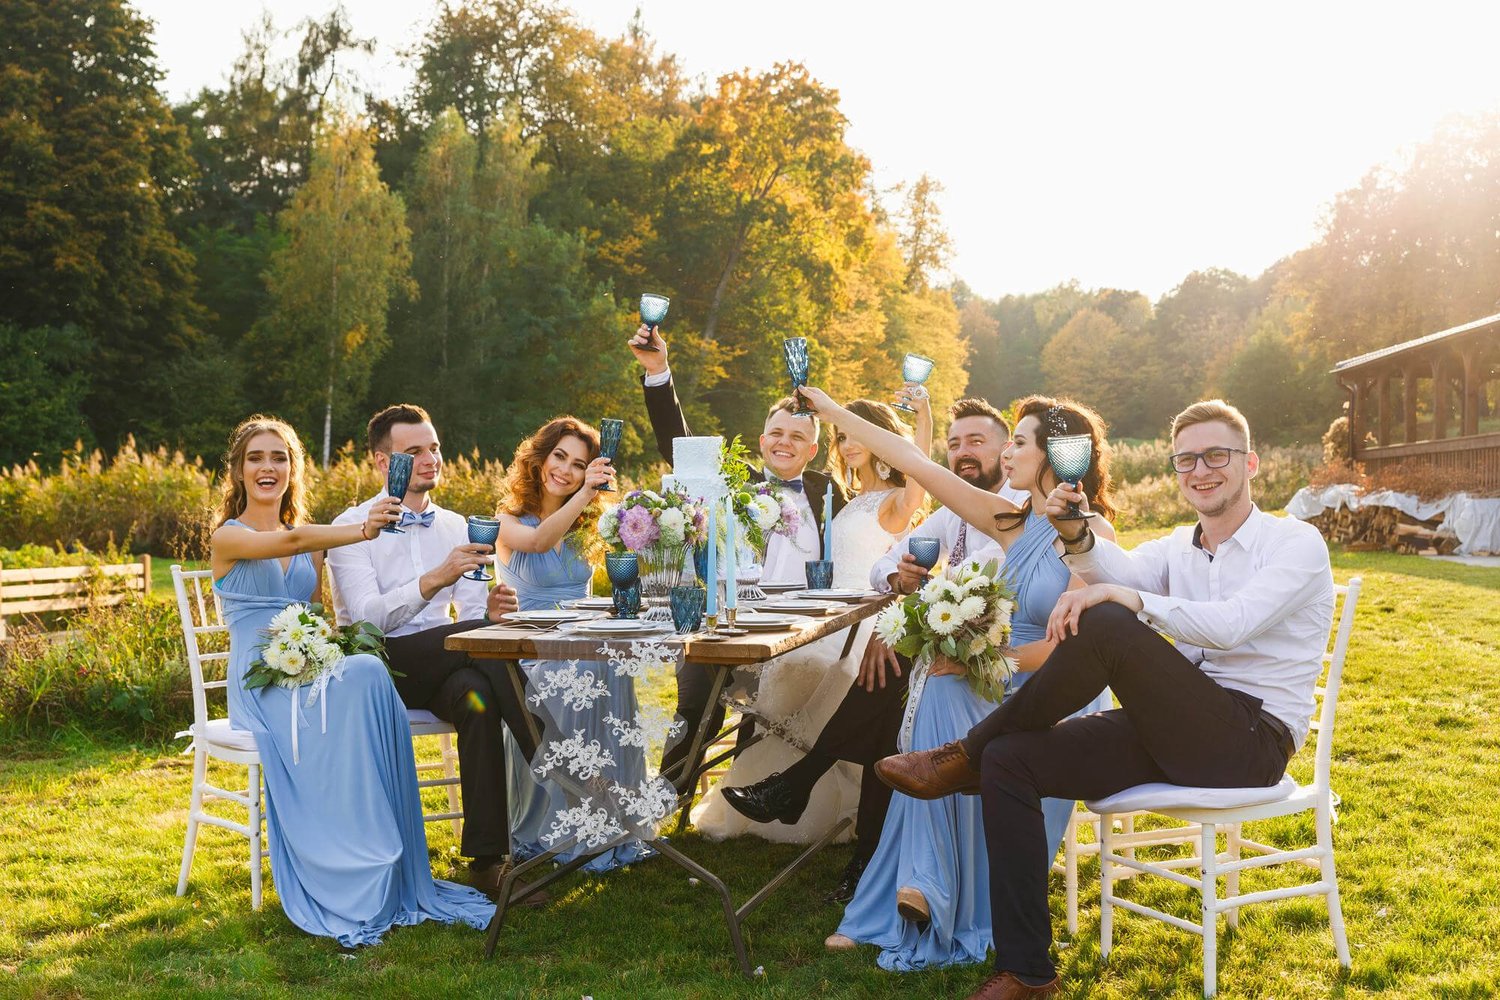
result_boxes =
[963,603,1292,978]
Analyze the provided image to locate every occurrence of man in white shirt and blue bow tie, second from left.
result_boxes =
[327,403,536,897]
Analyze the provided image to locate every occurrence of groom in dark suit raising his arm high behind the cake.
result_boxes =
[630,325,849,790]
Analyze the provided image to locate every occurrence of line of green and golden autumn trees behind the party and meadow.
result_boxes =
[0,0,1500,465]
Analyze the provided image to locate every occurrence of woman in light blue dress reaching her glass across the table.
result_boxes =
[803,390,1115,972]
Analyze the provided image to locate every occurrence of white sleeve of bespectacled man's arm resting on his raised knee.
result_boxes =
[1136,537,1331,649]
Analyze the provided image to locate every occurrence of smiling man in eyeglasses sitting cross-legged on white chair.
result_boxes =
[876,399,1334,1000]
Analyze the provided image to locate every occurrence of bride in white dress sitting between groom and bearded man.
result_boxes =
[693,388,933,844]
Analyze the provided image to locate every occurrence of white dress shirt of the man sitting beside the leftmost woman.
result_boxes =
[327,493,489,636]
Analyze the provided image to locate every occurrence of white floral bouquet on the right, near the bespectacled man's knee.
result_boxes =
[875,559,1017,702]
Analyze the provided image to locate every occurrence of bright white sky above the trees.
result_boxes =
[134,0,1500,298]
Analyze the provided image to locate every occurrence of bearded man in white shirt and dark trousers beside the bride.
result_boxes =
[723,399,1029,903]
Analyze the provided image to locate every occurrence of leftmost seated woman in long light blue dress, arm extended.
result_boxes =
[212,417,495,948]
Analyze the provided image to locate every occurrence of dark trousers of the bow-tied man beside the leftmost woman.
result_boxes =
[386,621,536,858]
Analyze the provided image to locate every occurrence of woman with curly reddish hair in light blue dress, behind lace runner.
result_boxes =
[497,417,656,873]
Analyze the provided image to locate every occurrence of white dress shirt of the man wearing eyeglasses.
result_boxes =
[1064,507,1334,747]
